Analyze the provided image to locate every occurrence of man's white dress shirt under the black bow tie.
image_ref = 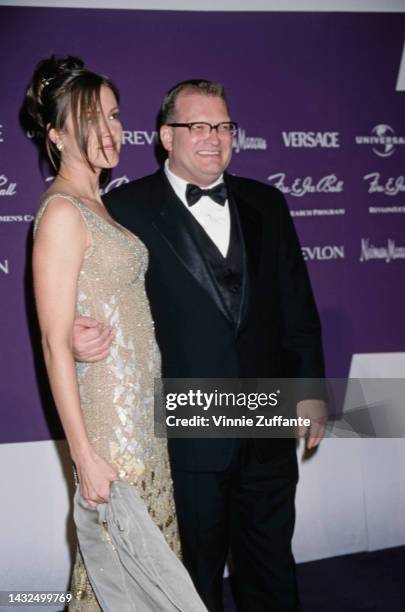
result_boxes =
[164,159,231,257]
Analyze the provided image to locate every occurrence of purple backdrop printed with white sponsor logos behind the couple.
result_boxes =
[0,7,405,442]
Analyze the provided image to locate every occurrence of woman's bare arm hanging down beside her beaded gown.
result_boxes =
[33,197,118,507]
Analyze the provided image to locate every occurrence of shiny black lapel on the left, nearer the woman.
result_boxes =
[151,171,230,320]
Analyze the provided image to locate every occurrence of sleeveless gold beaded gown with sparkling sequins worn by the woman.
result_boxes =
[34,193,180,612]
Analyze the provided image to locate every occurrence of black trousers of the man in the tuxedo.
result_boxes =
[173,440,298,612]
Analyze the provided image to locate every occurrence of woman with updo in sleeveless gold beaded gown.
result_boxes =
[26,57,186,612]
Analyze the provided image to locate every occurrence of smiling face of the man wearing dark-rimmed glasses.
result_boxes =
[160,92,232,187]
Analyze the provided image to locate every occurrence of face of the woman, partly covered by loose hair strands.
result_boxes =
[56,85,122,170]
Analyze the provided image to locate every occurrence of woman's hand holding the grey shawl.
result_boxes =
[75,449,119,508]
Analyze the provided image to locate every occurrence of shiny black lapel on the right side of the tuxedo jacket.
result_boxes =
[224,174,262,327]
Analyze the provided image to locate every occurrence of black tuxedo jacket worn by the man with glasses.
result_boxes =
[104,170,324,471]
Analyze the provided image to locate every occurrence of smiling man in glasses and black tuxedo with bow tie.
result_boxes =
[74,81,324,612]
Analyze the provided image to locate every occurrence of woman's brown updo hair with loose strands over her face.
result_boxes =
[23,55,119,171]
